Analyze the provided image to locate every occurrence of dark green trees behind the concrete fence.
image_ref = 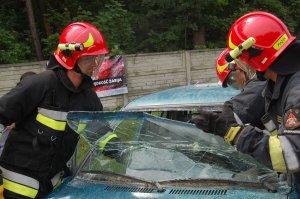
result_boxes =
[0,0,300,64]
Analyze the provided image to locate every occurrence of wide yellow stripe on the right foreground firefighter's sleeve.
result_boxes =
[269,134,286,173]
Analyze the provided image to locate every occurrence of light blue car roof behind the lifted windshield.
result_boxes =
[122,83,240,111]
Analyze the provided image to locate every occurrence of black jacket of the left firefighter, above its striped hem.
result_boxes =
[0,67,103,196]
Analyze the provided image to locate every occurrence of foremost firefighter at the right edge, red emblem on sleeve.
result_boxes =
[212,11,300,194]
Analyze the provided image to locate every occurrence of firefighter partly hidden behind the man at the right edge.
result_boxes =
[190,49,266,136]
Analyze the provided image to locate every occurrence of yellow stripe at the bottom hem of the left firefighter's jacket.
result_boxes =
[3,178,38,198]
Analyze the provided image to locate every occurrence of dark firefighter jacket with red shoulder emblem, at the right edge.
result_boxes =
[237,71,300,173]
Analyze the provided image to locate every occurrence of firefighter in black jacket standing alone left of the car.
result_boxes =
[0,22,116,198]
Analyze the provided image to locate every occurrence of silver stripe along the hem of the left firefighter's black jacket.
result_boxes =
[0,166,40,190]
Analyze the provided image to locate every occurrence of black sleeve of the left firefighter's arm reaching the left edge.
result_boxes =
[0,71,53,125]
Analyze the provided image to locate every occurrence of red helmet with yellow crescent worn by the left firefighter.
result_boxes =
[54,22,109,70]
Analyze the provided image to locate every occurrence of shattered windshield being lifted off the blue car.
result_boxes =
[68,111,288,192]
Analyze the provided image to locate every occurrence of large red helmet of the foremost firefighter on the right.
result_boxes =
[227,11,296,71]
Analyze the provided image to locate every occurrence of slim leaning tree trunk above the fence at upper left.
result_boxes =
[25,0,43,61]
